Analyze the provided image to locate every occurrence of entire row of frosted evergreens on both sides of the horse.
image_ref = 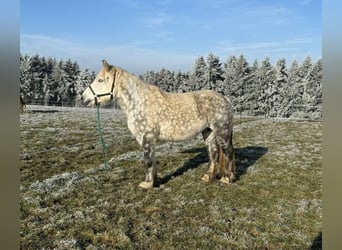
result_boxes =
[20,53,322,119]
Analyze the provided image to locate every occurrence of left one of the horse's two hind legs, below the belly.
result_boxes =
[202,128,218,182]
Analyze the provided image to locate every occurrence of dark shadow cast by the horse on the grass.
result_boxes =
[159,146,268,184]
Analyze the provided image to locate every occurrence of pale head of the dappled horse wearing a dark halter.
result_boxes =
[82,60,117,106]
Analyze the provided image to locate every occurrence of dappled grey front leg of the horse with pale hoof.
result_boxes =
[139,139,157,189]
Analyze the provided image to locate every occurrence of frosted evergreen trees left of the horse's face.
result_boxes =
[20,55,96,106]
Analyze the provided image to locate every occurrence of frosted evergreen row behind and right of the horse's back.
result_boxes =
[141,53,322,119]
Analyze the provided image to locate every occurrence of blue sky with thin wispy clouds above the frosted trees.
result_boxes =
[20,0,322,74]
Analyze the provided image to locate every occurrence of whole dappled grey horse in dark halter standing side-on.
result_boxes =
[82,60,235,188]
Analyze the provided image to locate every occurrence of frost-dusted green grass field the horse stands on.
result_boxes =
[20,106,322,249]
